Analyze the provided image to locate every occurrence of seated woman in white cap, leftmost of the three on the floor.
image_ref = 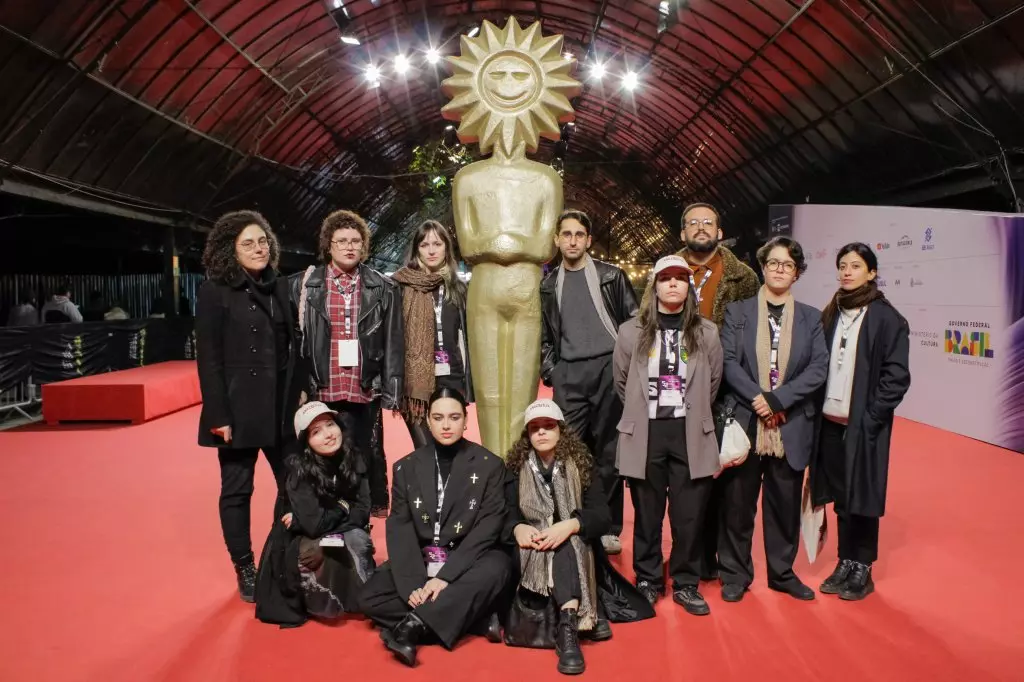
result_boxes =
[256,401,374,628]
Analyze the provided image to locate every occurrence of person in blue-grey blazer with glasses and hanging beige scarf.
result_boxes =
[718,237,828,601]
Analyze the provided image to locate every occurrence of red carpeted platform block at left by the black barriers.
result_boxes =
[42,360,202,424]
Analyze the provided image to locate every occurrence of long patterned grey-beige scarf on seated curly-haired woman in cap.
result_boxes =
[519,452,597,631]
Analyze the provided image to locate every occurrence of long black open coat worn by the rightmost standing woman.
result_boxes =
[811,299,910,517]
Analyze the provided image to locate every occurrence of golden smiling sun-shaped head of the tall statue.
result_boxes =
[441,16,581,155]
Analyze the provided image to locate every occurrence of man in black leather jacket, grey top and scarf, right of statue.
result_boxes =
[541,211,637,554]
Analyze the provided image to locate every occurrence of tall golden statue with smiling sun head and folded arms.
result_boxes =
[441,17,581,457]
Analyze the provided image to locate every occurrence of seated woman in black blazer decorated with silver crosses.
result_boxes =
[361,387,511,666]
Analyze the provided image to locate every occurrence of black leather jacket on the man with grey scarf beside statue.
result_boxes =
[541,258,639,386]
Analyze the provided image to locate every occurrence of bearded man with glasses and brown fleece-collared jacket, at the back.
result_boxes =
[678,204,761,581]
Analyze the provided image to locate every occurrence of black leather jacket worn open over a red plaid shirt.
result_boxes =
[290,265,406,410]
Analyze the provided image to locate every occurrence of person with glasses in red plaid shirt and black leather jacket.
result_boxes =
[292,211,406,516]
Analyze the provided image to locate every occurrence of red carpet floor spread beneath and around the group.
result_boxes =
[0,401,1024,682]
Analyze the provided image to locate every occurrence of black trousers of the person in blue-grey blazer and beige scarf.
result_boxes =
[718,453,804,587]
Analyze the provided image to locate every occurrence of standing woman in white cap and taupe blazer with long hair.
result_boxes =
[614,251,722,615]
